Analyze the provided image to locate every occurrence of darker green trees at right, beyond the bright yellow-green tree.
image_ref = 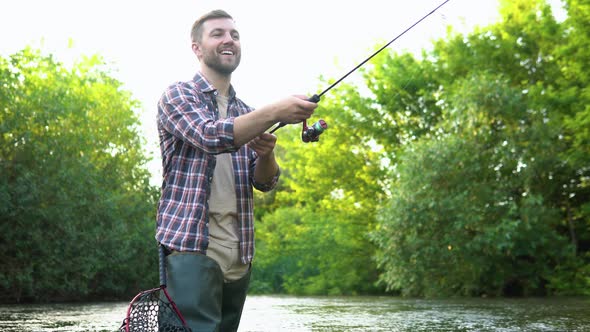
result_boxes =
[367,1,590,296]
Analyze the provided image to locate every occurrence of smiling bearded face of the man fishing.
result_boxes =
[193,18,242,75]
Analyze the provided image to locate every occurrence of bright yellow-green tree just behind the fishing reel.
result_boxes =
[254,81,384,294]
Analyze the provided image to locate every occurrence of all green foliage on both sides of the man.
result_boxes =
[0,0,590,301]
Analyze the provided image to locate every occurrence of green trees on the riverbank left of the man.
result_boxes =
[0,48,157,302]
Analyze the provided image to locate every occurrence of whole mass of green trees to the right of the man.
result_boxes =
[256,0,590,296]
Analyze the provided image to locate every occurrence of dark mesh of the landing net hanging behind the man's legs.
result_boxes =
[119,288,191,332]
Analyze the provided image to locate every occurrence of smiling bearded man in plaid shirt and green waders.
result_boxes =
[156,10,317,332]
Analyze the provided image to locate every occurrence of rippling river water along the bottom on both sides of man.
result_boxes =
[0,295,590,332]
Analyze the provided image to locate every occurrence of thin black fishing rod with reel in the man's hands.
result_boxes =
[270,0,451,143]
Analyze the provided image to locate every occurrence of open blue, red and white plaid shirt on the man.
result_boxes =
[156,73,280,264]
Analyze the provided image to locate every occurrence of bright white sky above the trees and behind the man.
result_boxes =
[0,0,508,183]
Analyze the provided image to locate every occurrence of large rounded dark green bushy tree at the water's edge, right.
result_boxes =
[375,76,568,296]
